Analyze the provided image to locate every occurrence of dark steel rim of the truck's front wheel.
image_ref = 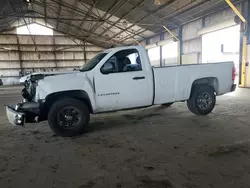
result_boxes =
[57,106,82,129]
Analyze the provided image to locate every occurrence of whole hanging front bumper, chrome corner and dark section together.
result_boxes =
[6,102,41,126]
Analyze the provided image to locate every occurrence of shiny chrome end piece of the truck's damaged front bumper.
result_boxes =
[6,106,26,126]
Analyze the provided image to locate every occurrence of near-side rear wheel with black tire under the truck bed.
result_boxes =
[187,85,216,115]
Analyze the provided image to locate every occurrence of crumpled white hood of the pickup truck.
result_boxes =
[19,71,77,84]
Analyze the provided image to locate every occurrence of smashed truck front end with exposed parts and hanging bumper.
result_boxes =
[6,75,43,126]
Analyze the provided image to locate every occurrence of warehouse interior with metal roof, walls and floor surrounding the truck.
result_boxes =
[0,0,250,188]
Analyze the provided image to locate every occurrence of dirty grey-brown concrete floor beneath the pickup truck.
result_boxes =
[0,87,250,188]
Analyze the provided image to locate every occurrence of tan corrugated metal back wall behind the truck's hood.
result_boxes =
[0,31,102,85]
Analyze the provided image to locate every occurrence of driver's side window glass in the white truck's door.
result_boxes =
[101,49,142,74]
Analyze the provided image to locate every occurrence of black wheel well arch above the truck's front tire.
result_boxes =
[40,90,93,120]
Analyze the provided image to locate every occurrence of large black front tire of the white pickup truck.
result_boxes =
[48,98,90,137]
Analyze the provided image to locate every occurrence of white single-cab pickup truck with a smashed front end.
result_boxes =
[6,46,236,136]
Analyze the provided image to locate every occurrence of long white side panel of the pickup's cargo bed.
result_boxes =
[153,62,234,104]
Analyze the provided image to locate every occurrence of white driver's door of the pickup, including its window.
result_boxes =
[95,49,152,112]
